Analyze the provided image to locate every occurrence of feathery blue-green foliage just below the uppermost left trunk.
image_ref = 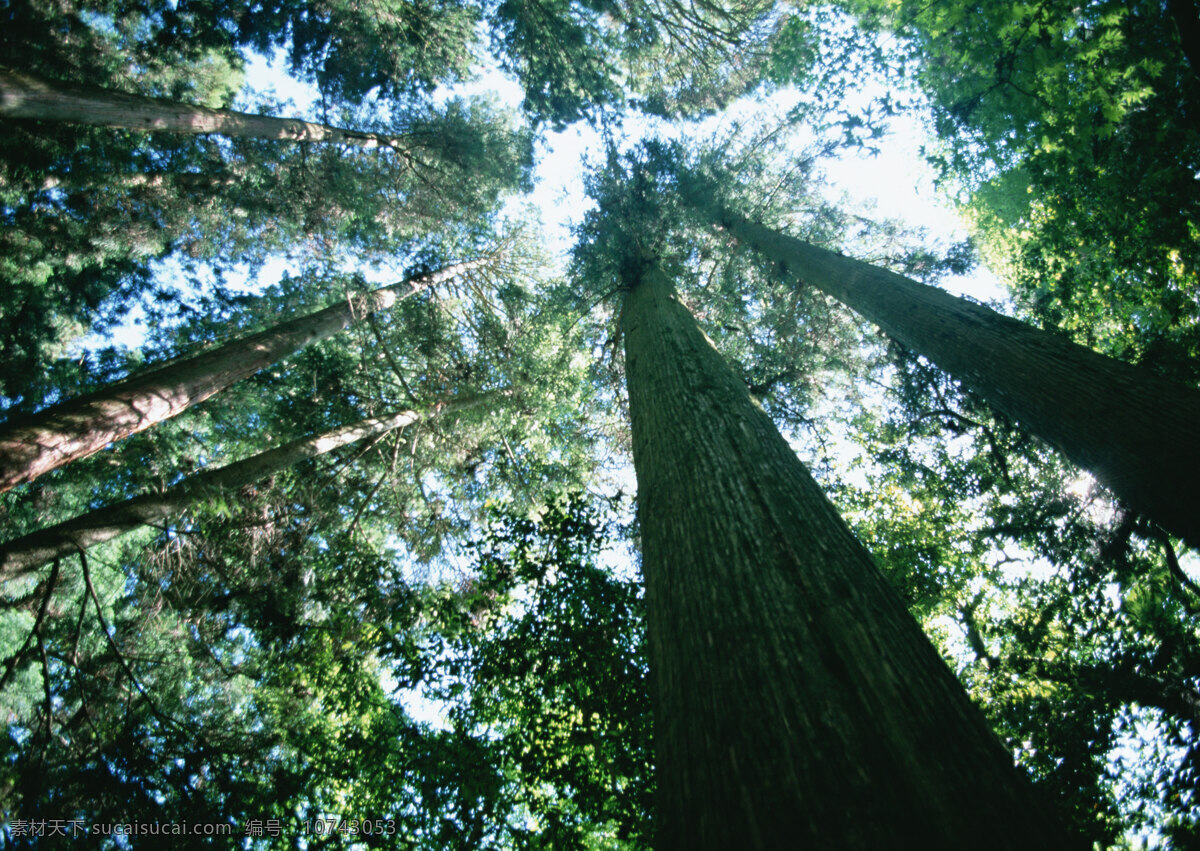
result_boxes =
[0,91,532,410]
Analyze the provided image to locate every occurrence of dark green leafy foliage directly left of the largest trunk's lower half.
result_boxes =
[434,495,652,849]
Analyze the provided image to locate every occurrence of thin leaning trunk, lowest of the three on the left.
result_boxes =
[0,394,496,581]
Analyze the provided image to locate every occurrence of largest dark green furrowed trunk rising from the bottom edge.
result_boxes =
[622,261,1069,851]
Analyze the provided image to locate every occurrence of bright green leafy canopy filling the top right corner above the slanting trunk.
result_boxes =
[846,0,1200,384]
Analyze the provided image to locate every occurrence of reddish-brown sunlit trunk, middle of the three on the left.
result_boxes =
[0,260,485,492]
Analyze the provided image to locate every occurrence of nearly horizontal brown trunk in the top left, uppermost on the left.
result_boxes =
[0,67,403,149]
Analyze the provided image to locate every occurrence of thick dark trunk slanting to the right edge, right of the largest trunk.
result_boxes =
[718,211,1200,546]
